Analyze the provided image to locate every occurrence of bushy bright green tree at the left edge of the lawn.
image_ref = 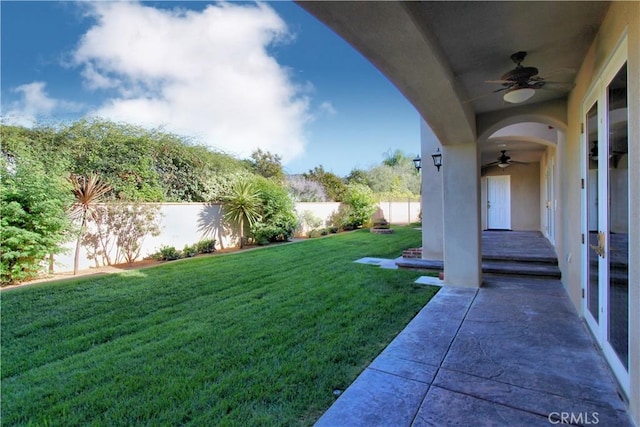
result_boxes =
[0,156,71,285]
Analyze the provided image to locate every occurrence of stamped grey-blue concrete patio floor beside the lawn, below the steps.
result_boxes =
[316,276,632,427]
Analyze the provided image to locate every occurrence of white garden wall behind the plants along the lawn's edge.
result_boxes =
[54,201,420,272]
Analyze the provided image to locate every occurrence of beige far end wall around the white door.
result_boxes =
[480,163,541,231]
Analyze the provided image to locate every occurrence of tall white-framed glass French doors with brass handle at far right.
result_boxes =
[583,42,629,391]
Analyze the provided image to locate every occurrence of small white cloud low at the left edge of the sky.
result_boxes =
[2,82,80,127]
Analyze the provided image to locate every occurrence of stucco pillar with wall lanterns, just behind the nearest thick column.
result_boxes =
[420,120,444,261]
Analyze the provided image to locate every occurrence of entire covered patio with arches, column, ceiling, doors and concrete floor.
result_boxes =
[299,1,640,425]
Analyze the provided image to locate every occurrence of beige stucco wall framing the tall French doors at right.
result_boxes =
[559,2,640,425]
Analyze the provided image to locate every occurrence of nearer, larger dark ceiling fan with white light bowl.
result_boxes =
[486,51,558,104]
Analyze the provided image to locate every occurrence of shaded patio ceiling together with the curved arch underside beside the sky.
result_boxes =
[298,1,608,158]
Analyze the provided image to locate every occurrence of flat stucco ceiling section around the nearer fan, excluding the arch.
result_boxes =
[410,1,607,113]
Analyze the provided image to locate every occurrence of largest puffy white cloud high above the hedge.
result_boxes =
[74,2,310,162]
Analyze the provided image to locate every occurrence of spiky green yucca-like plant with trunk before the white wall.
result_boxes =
[224,180,261,248]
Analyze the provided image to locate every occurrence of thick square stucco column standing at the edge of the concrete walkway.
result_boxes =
[440,143,482,287]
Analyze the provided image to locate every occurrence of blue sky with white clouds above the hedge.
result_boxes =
[0,1,420,176]
